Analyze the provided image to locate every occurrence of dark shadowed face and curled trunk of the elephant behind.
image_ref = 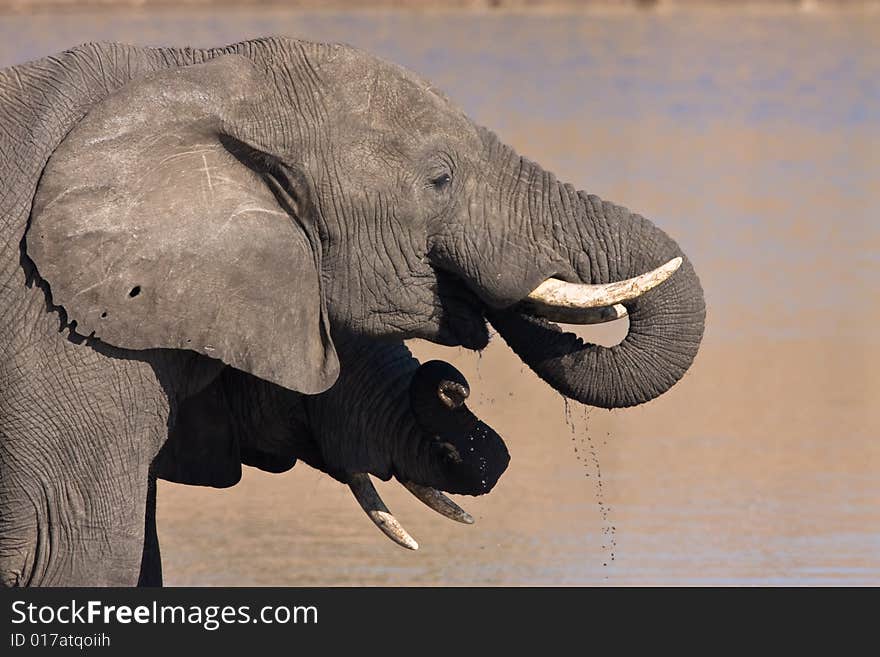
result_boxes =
[304,332,510,495]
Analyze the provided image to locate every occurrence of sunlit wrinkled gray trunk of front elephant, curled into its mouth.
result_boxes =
[487,181,706,408]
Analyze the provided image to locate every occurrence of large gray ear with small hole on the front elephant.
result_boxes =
[27,55,339,394]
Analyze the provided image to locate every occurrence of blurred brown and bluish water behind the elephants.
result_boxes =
[0,8,880,585]
